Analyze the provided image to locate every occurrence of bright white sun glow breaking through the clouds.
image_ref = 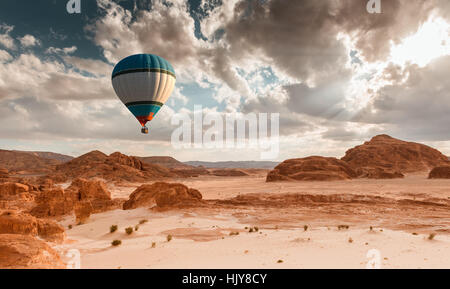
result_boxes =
[391,18,450,67]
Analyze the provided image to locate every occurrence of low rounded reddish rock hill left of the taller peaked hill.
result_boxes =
[266,156,356,182]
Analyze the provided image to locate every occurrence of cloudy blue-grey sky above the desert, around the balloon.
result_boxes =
[0,0,450,161]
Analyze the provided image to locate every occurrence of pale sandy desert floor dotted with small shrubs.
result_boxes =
[58,175,450,268]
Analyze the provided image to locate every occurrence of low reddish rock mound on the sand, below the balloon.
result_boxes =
[123,182,202,210]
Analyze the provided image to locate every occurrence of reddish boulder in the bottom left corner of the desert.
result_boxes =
[0,234,66,269]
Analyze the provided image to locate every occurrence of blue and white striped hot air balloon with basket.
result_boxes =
[112,54,176,134]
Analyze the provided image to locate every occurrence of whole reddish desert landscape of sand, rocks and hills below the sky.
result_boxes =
[0,135,450,269]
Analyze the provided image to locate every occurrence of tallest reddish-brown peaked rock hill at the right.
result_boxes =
[342,135,448,174]
